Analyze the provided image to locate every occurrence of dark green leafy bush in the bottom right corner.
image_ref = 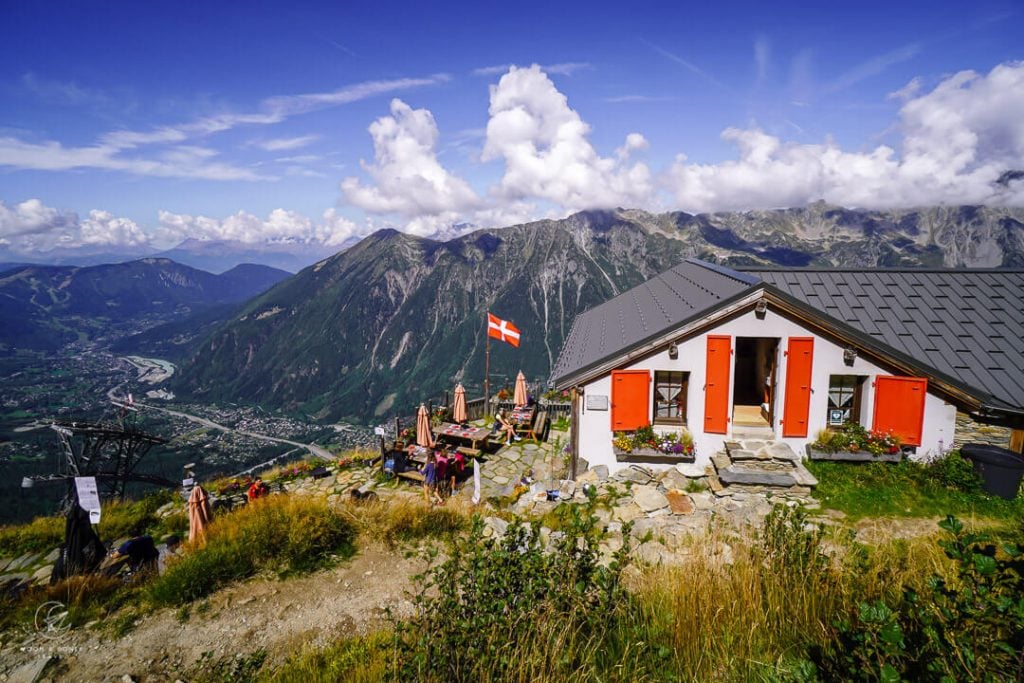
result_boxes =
[818,515,1024,681]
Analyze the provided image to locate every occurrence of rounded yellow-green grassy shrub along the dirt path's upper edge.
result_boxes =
[146,496,354,605]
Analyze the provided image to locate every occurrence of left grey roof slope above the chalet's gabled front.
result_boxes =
[551,259,759,383]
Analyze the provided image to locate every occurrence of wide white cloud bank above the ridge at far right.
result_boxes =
[668,62,1024,211]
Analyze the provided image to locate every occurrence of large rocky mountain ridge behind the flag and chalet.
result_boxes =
[174,203,1024,422]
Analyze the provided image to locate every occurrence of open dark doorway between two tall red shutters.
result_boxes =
[732,337,778,428]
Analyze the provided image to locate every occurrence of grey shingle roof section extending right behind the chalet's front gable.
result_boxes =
[744,268,1024,408]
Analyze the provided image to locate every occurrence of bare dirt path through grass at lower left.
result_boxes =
[41,545,424,682]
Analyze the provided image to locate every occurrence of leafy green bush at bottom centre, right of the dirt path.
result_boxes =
[393,505,637,681]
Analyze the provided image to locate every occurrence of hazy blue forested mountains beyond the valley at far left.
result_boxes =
[0,258,290,353]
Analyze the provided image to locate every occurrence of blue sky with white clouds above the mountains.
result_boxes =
[0,1,1024,253]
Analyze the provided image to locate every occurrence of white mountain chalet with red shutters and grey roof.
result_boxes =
[551,259,1024,472]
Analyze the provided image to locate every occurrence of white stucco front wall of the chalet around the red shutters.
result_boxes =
[577,309,956,472]
